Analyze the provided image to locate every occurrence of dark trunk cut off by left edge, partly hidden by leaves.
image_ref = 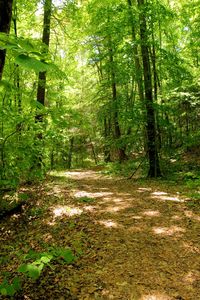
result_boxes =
[0,0,13,80]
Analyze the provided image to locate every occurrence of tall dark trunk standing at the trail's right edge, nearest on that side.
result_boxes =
[137,0,161,177]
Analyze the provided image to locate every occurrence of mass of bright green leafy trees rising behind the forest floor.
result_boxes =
[0,0,200,185]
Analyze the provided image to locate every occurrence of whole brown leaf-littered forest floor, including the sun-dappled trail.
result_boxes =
[0,169,200,300]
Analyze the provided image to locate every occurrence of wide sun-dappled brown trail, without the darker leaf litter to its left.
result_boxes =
[48,170,200,300]
